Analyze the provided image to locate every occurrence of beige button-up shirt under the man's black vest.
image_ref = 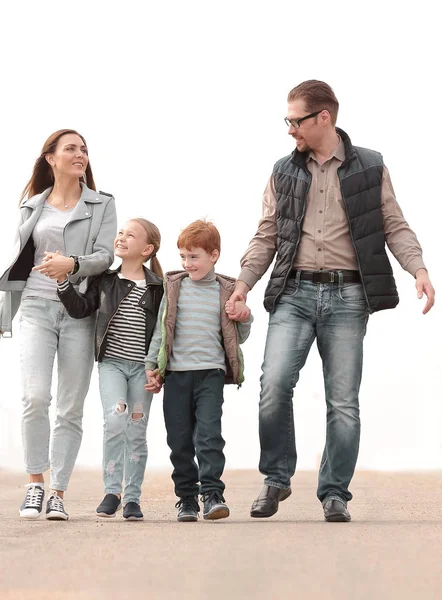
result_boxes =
[238,140,425,288]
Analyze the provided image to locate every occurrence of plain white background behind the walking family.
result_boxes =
[0,0,442,470]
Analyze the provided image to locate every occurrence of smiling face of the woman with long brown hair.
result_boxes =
[46,133,89,179]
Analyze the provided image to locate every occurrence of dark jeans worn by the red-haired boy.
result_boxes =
[163,369,225,497]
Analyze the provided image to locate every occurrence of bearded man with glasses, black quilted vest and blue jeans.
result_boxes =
[227,80,434,521]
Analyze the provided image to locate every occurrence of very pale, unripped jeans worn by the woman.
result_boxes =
[20,297,95,490]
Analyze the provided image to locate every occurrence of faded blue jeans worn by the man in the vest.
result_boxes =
[259,274,368,502]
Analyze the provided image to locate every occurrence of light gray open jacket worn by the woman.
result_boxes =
[0,183,117,337]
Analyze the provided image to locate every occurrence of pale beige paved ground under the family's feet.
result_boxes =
[0,471,442,600]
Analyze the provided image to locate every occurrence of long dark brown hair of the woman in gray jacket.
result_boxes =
[20,129,96,204]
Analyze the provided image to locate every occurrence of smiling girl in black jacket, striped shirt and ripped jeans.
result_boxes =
[58,219,163,520]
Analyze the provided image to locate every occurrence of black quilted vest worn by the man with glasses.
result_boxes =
[264,128,399,313]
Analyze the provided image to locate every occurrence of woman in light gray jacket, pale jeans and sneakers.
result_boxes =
[0,129,117,520]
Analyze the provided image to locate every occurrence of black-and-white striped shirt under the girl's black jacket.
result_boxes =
[104,273,146,363]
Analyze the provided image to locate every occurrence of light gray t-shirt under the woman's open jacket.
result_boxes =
[22,202,75,300]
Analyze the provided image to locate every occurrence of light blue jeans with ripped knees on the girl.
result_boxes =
[98,358,152,504]
